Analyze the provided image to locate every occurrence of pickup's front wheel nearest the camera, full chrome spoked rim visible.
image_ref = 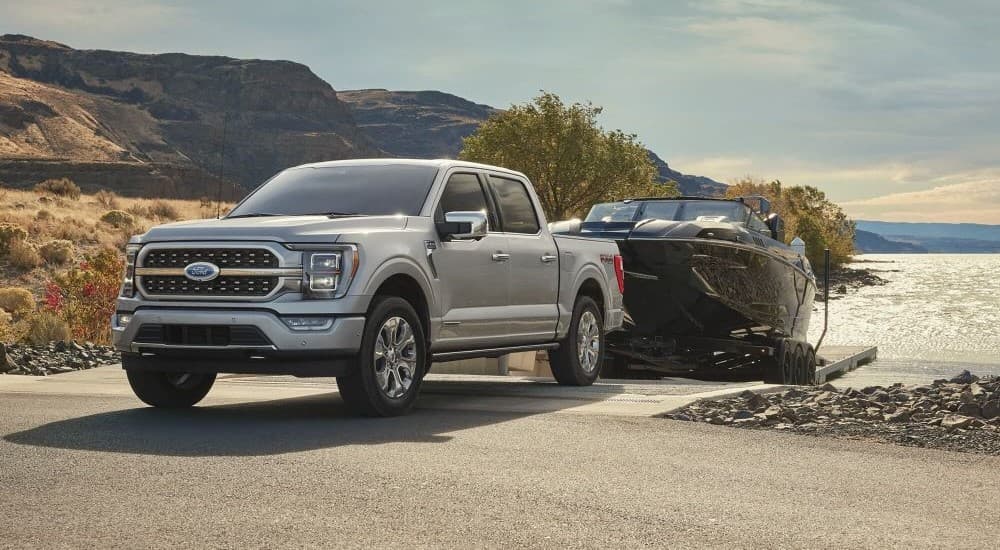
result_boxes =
[337,296,427,416]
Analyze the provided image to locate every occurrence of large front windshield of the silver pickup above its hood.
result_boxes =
[233,164,437,217]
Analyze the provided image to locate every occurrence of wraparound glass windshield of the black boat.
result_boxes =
[584,200,748,223]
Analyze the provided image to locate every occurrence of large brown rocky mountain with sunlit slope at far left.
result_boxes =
[0,35,384,196]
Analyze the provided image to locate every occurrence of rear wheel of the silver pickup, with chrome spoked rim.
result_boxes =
[549,296,604,386]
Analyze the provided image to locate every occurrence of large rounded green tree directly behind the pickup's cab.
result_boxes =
[459,92,677,220]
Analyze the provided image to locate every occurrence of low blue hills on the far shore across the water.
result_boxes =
[856,220,1000,253]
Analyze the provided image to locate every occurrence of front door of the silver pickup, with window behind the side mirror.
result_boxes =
[433,172,510,351]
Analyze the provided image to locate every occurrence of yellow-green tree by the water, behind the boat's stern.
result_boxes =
[726,176,854,269]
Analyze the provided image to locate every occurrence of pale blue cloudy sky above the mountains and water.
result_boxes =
[0,0,1000,224]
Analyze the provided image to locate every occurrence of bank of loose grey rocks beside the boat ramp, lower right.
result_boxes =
[666,371,1000,455]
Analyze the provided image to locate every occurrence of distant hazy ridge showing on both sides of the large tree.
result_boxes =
[337,89,726,196]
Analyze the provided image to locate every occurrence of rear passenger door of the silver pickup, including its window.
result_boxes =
[489,173,559,343]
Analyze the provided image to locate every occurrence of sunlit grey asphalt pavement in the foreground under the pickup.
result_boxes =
[0,369,1000,548]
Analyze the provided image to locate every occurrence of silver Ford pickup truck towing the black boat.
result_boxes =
[112,159,624,416]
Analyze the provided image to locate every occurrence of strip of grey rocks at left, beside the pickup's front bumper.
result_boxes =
[0,342,121,376]
